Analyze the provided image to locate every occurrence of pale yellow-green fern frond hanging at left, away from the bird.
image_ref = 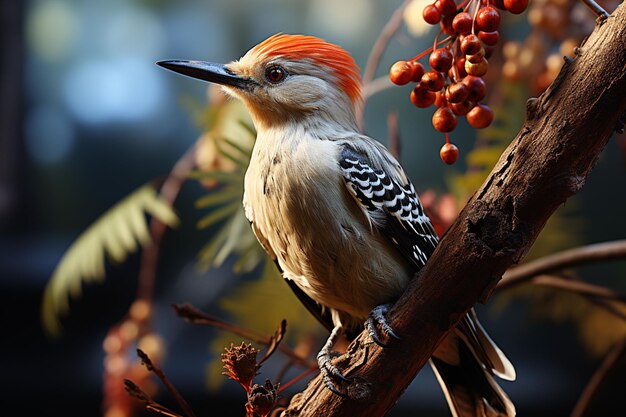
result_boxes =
[41,185,179,336]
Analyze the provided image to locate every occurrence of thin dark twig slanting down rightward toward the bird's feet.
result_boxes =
[172,304,317,368]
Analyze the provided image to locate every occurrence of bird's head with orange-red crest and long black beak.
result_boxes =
[158,34,362,128]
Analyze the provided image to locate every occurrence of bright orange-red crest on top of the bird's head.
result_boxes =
[254,33,362,104]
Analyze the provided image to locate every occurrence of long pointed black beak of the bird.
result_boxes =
[157,60,252,89]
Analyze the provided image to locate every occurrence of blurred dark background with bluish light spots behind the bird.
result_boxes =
[0,0,626,417]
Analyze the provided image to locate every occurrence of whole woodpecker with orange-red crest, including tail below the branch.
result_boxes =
[157,33,515,417]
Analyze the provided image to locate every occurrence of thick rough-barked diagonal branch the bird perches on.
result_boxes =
[283,4,626,416]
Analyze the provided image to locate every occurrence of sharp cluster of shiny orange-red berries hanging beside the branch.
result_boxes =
[389,0,528,164]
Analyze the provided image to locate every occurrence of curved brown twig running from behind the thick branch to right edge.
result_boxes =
[497,240,626,289]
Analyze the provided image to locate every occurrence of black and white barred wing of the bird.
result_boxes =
[339,147,439,270]
